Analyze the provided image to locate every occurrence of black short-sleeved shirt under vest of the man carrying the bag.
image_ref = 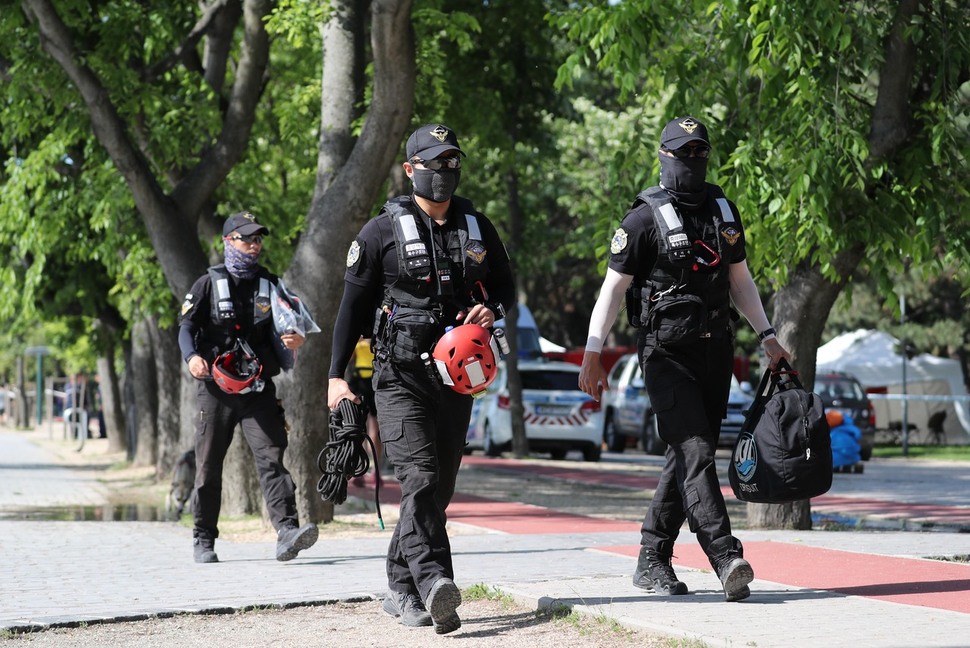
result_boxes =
[609,185,746,282]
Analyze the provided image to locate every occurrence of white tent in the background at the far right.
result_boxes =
[816,329,970,439]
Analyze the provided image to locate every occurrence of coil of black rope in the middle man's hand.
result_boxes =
[317,398,384,529]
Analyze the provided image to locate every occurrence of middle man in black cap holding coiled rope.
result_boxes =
[327,124,515,634]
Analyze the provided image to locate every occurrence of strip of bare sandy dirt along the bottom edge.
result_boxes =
[0,599,688,648]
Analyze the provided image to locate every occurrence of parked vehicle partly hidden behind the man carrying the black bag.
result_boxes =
[603,353,754,455]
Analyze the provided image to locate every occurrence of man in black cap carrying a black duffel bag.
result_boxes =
[579,117,791,601]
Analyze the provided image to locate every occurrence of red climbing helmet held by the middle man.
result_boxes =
[433,324,499,398]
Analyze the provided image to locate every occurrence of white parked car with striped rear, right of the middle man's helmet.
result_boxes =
[466,359,603,461]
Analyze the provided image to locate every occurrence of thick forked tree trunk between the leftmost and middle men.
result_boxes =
[279,0,416,522]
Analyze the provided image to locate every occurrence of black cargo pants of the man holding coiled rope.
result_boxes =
[373,360,472,600]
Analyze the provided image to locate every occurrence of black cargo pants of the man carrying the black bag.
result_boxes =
[640,336,734,556]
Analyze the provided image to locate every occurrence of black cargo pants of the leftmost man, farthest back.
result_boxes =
[192,380,297,538]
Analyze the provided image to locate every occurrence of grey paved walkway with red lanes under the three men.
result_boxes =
[0,431,970,648]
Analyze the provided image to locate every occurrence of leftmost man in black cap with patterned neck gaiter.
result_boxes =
[179,212,318,563]
